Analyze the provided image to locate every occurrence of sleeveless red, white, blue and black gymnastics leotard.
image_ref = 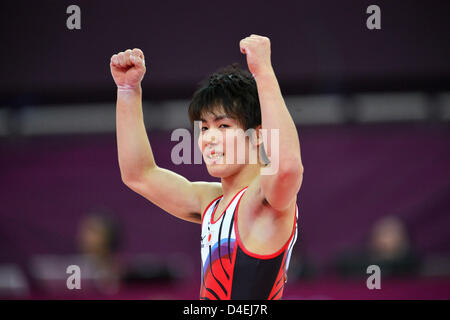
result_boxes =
[200,187,298,300]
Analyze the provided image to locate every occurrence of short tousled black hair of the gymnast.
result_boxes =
[189,63,261,130]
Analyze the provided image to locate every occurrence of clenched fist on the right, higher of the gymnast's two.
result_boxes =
[239,34,273,77]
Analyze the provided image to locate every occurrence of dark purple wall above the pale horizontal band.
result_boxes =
[0,0,450,102]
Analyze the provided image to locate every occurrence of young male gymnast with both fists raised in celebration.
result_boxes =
[110,35,303,299]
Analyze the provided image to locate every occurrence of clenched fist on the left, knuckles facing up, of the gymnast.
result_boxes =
[110,49,145,89]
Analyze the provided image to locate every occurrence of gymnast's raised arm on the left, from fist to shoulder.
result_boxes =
[110,49,219,223]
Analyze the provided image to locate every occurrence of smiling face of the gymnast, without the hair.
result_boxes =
[198,108,258,178]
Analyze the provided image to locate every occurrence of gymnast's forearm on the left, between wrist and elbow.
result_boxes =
[116,86,156,182]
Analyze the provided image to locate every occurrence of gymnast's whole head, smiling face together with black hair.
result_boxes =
[188,64,261,178]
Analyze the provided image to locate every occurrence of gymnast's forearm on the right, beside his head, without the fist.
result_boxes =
[255,70,301,168]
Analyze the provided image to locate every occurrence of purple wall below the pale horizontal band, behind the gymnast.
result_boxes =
[0,124,450,277]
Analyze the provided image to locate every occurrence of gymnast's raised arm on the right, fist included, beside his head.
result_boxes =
[240,35,303,211]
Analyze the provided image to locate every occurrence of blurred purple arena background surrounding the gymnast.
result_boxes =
[0,1,450,299]
